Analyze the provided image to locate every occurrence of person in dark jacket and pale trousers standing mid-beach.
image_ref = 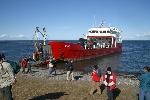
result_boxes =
[65,60,74,80]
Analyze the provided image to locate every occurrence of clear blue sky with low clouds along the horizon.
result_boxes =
[0,0,150,40]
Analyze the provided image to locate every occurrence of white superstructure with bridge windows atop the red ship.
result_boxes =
[84,24,122,47]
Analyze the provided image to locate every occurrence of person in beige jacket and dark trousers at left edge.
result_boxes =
[0,54,16,100]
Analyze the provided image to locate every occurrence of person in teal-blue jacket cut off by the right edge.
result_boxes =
[138,66,150,100]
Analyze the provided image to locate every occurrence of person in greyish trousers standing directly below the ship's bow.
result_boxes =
[48,58,56,77]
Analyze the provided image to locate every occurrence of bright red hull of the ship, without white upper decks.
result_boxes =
[48,41,122,60]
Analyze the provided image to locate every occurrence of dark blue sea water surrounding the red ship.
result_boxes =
[0,40,150,72]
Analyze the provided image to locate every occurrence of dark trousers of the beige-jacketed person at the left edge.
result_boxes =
[0,86,13,100]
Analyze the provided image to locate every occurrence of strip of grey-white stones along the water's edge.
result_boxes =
[20,67,139,86]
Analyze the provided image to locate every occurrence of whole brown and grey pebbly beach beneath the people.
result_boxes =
[2,68,139,100]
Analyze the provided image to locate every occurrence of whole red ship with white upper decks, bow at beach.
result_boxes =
[48,23,122,60]
